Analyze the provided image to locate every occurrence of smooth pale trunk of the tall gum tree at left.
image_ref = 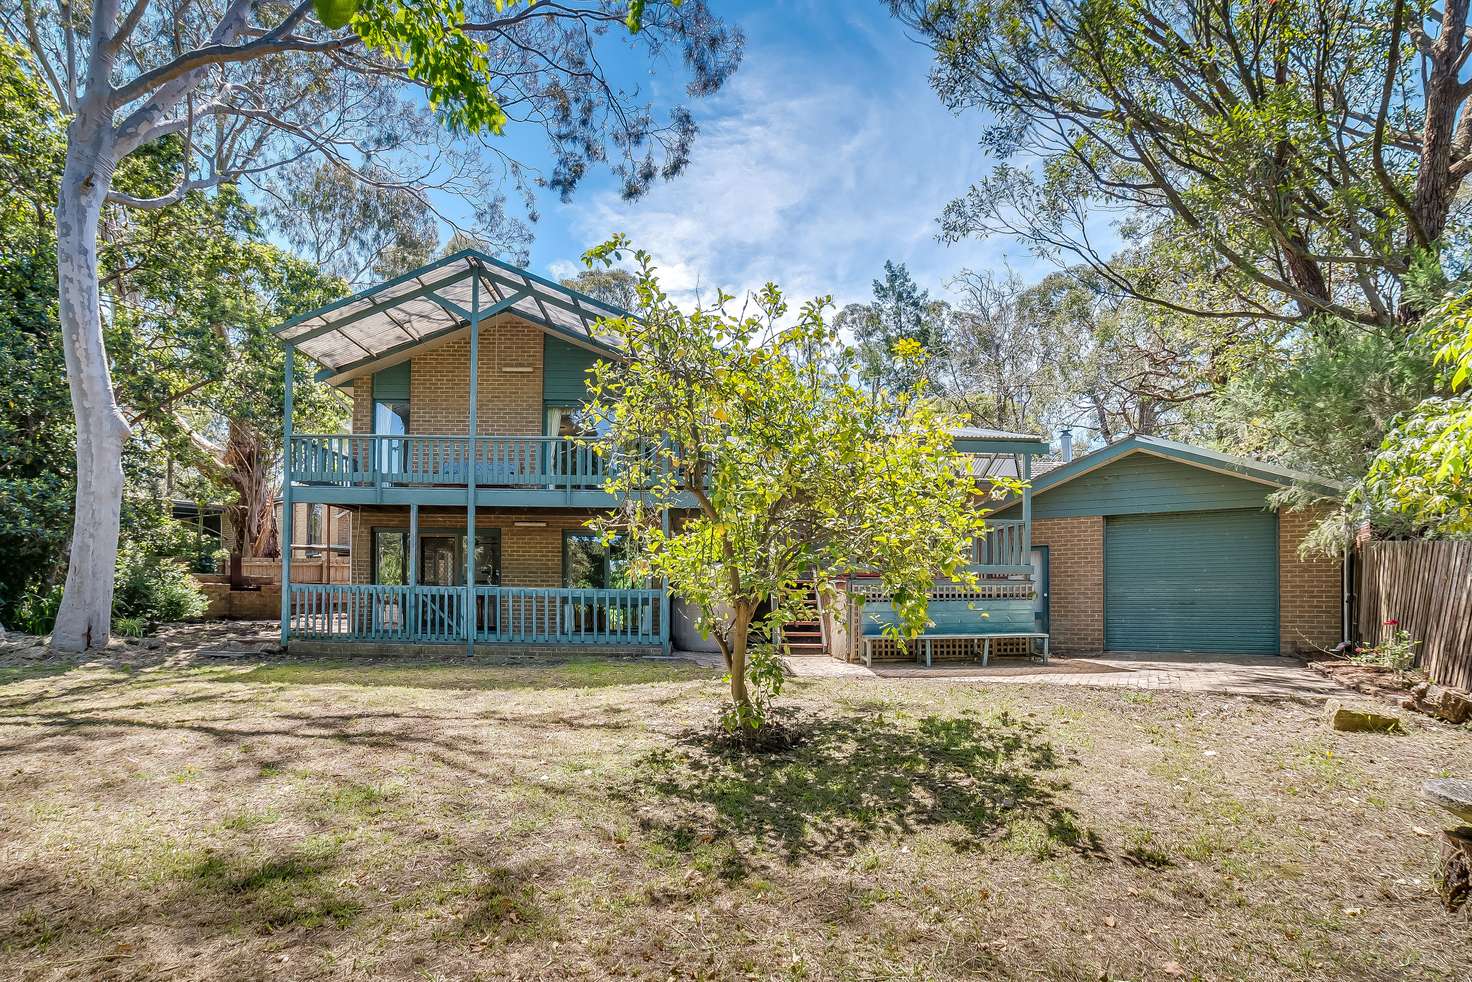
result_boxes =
[52,101,130,651]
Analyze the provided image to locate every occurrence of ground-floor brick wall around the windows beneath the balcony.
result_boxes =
[352,508,606,586]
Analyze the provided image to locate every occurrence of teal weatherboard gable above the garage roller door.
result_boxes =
[1008,453,1276,518]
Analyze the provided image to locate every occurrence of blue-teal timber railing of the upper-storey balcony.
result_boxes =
[287,434,608,490]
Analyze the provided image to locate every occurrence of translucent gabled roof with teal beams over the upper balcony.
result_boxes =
[272,249,630,383]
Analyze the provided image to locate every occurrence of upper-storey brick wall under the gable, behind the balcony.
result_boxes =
[353,315,543,436]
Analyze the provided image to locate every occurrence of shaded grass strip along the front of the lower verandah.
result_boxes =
[216,657,717,690]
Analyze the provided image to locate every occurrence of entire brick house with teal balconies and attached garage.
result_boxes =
[267,252,1347,660]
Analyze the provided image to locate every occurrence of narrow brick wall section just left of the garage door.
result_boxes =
[1032,515,1104,655]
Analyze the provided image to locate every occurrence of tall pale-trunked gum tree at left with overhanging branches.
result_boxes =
[0,0,742,651]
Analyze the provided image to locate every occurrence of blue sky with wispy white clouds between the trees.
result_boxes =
[471,0,1045,305]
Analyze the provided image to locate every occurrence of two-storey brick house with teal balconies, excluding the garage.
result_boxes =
[277,250,1047,649]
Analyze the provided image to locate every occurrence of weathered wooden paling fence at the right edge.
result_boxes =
[1359,542,1472,689]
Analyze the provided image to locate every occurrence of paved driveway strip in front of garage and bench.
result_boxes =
[786,651,1348,698]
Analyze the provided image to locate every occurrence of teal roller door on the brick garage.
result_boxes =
[1104,508,1278,654]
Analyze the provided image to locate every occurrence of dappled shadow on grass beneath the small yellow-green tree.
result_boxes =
[618,713,1104,879]
